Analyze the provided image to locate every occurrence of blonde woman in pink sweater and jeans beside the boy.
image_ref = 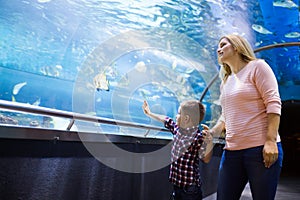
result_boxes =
[204,35,283,200]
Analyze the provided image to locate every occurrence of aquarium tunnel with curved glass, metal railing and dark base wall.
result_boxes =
[0,0,300,200]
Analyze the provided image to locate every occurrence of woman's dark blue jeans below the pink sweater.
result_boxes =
[217,143,283,200]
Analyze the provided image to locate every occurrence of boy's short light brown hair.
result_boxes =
[180,100,205,125]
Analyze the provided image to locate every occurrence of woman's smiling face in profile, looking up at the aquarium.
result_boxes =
[217,38,236,63]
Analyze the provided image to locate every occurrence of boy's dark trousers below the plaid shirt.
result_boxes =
[172,185,202,200]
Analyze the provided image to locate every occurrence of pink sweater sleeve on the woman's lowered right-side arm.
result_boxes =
[254,60,281,115]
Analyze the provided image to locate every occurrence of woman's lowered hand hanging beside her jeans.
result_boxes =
[263,141,278,168]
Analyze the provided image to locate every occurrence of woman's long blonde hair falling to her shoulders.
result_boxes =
[218,34,256,82]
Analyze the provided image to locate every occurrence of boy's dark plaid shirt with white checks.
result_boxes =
[165,117,203,188]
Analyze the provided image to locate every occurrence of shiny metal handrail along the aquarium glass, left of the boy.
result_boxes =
[0,100,169,136]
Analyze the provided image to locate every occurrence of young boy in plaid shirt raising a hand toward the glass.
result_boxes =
[143,100,213,200]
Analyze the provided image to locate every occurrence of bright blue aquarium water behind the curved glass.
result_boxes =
[0,0,300,136]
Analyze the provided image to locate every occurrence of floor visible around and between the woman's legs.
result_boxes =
[204,176,300,200]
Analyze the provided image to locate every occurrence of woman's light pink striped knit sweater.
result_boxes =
[220,59,281,150]
